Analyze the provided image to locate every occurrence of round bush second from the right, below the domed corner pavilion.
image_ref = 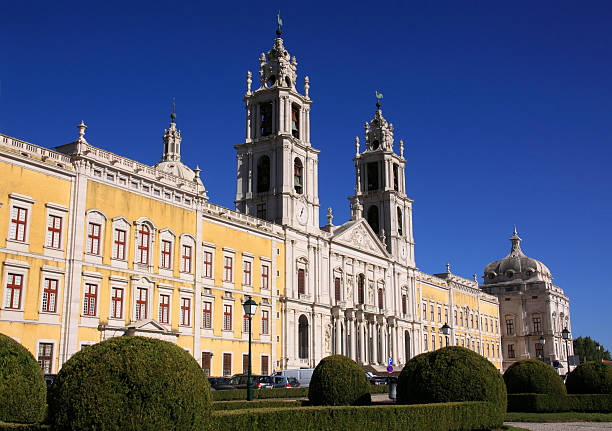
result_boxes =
[504,359,566,395]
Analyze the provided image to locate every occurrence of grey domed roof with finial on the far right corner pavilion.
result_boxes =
[484,228,552,284]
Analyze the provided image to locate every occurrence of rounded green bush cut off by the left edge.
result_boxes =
[0,334,47,423]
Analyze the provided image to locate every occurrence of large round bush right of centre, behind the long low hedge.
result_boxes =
[397,346,507,425]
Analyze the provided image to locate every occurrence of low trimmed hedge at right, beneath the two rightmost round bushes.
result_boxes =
[508,394,612,413]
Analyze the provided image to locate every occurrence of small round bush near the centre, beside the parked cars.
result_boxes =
[308,355,371,406]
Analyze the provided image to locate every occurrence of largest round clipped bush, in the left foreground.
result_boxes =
[49,336,212,430]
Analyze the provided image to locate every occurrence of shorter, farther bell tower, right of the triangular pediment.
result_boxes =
[349,98,414,266]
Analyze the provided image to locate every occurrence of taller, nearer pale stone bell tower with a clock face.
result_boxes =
[234,20,319,232]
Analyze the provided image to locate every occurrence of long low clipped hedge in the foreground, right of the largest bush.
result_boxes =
[213,401,501,431]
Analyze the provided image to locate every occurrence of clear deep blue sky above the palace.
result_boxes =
[0,1,612,348]
